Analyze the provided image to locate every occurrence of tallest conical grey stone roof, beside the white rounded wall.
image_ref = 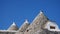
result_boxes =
[25,10,48,33]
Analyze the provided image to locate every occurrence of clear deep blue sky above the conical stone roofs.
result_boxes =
[0,0,60,29]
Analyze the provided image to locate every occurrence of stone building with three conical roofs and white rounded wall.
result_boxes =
[0,11,60,34]
